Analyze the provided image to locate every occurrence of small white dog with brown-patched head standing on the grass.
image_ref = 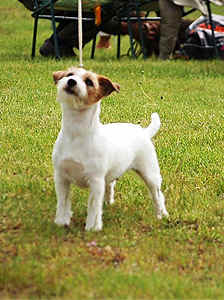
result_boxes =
[53,68,168,230]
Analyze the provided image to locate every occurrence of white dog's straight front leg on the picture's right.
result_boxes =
[86,178,105,231]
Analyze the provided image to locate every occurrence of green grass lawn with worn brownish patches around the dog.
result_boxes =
[0,0,224,300]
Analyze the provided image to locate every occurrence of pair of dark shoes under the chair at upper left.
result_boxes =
[40,39,76,57]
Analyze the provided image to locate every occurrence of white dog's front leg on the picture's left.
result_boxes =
[54,172,72,226]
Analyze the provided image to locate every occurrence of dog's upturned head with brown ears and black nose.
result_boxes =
[53,67,120,110]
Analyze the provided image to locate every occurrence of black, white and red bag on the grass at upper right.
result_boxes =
[180,14,224,59]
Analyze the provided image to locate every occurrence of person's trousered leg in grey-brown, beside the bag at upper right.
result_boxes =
[159,0,182,59]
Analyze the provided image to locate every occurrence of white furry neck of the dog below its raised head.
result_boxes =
[61,102,101,138]
